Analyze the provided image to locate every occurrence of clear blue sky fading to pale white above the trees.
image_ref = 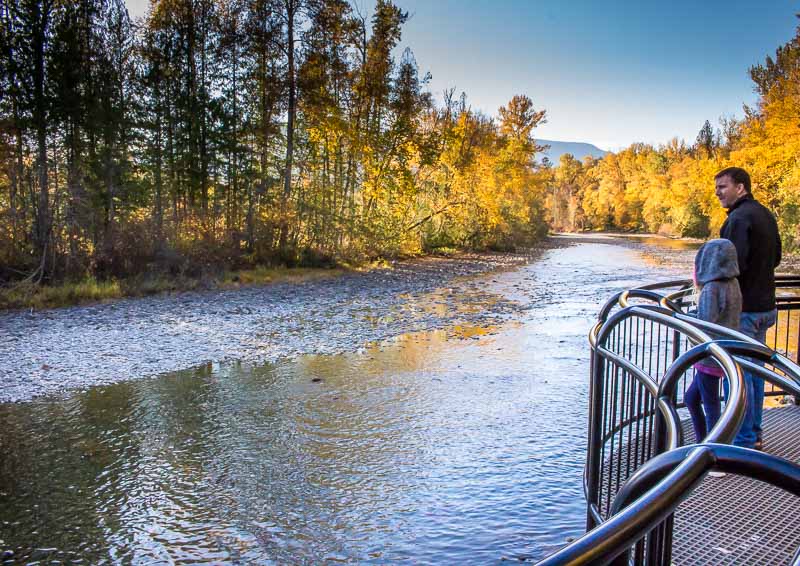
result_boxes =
[127,0,800,150]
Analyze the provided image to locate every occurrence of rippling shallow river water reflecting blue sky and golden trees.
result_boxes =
[0,238,693,564]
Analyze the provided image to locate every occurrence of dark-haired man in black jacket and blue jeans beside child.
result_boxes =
[714,167,781,450]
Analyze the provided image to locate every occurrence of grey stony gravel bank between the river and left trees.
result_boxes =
[0,244,567,402]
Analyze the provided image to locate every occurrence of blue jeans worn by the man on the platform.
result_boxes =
[725,309,778,448]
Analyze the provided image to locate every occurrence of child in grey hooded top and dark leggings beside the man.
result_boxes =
[684,239,742,442]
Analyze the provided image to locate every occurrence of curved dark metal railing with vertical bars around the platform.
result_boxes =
[541,276,800,566]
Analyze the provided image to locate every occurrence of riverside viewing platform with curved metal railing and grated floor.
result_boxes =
[541,276,800,566]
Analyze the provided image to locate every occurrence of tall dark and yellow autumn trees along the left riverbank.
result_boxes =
[0,0,549,302]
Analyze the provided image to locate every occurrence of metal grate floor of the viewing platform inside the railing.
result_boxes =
[673,405,800,566]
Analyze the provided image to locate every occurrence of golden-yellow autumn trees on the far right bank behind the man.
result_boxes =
[548,14,800,250]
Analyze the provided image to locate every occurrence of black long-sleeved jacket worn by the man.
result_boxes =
[719,195,781,312]
